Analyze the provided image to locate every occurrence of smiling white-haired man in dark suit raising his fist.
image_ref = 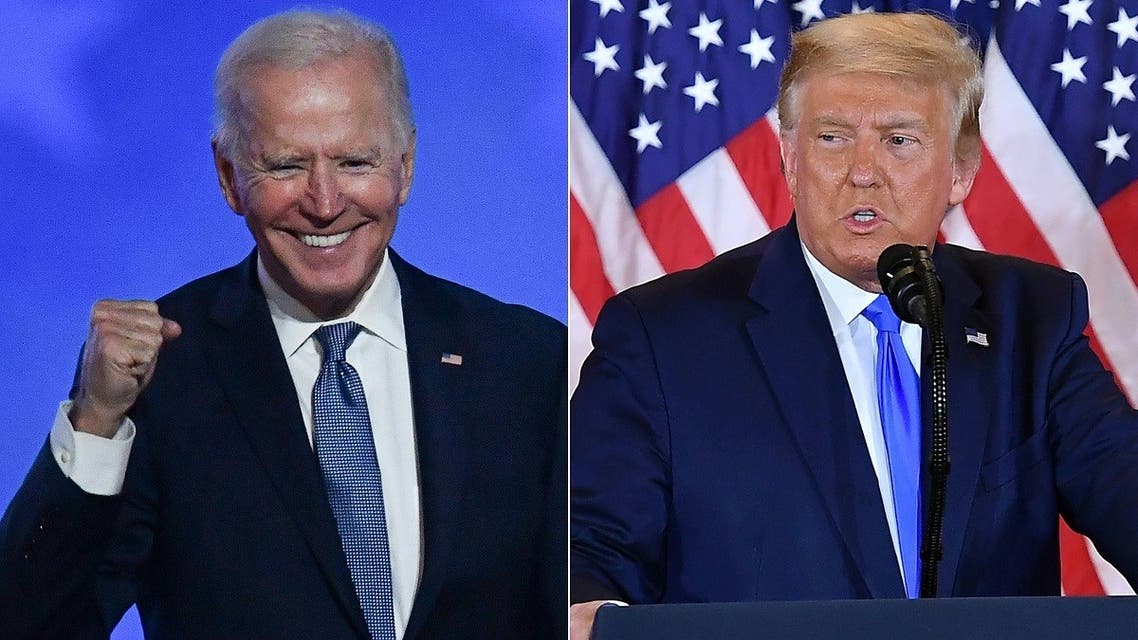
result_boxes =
[0,11,566,640]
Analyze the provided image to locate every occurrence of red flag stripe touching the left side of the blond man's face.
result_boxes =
[724,117,793,229]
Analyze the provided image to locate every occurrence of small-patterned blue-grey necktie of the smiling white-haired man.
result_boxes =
[312,322,395,640]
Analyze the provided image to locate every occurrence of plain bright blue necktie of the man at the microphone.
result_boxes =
[861,296,921,598]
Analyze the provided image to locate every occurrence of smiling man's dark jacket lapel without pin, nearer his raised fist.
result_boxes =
[205,254,368,637]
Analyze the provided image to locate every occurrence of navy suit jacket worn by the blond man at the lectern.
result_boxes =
[570,221,1138,604]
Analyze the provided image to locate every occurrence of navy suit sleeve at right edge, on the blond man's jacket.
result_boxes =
[1047,268,1138,586]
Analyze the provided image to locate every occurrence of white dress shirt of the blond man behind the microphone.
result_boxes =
[802,245,922,583]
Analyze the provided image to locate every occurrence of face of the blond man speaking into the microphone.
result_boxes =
[781,72,979,292]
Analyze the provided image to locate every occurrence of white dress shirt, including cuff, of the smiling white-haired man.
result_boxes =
[50,252,423,638]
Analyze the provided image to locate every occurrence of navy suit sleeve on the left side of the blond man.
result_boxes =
[570,295,671,604]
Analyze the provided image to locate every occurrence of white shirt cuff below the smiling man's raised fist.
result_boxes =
[49,401,134,495]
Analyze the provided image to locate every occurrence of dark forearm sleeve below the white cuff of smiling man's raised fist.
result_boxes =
[0,400,156,640]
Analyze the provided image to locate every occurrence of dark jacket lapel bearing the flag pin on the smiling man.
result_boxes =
[388,251,478,639]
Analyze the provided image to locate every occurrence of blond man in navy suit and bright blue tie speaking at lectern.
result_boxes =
[570,14,1138,638]
